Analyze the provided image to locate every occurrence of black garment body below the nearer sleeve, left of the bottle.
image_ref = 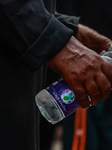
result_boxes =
[0,52,37,150]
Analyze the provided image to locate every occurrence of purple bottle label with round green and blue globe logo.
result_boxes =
[46,78,80,116]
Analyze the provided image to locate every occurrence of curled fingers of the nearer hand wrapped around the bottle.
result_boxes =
[74,73,111,108]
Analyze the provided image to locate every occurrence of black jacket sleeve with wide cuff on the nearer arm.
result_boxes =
[0,0,73,70]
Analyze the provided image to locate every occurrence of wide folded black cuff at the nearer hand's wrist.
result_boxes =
[18,15,73,71]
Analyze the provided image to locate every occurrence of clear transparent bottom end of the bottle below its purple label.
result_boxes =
[36,89,65,124]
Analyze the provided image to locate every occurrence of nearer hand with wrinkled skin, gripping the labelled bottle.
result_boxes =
[47,37,112,108]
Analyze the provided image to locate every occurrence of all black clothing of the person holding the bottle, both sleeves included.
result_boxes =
[0,0,78,150]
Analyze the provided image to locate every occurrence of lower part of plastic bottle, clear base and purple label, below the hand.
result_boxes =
[35,78,80,124]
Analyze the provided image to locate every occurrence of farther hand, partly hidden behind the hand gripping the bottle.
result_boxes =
[77,24,112,54]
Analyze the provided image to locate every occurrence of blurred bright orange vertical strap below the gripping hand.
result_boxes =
[72,108,87,150]
